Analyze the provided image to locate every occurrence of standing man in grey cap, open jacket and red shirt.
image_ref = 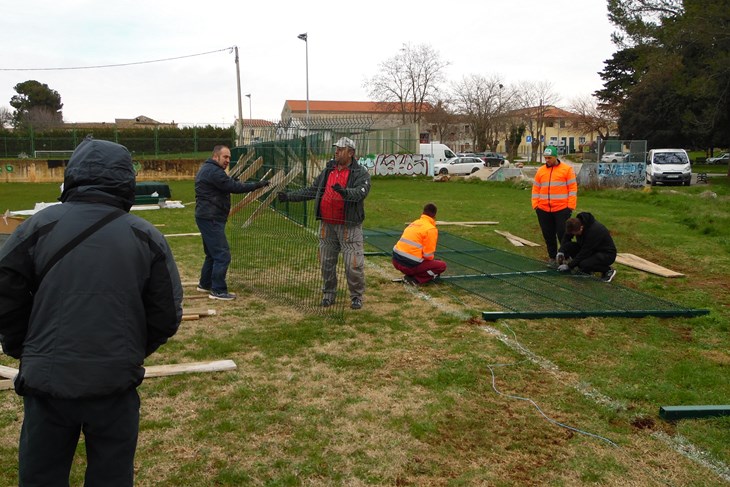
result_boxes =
[278,137,370,309]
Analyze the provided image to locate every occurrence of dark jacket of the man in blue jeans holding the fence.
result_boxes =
[195,159,261,222]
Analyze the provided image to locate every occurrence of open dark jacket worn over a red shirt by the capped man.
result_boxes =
[287,158,370,225]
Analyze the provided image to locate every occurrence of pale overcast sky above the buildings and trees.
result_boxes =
[0,0,616,125]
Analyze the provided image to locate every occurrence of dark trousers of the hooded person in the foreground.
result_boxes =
[18,388,139,487]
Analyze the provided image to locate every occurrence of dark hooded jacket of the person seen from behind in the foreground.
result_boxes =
[0,139,182,399]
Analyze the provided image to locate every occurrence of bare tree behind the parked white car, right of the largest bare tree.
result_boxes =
[453,74,511,151]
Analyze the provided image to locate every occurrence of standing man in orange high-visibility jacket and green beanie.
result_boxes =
[532,145,578,267]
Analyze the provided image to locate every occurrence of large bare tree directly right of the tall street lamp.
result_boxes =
[363,44,448,123]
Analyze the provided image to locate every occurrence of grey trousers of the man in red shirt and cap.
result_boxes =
[319,222,365,300]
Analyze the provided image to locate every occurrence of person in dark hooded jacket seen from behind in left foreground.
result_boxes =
[0,137,182,486]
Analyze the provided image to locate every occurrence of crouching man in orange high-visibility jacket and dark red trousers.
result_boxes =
[393,203,446,284]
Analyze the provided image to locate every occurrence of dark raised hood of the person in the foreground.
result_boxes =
[59,136,135,211]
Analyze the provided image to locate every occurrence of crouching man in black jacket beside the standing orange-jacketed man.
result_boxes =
[556,212,616,282]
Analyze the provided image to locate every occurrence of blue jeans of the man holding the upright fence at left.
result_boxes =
[195,218,231,293]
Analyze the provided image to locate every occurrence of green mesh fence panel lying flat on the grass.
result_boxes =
[365,230,708,320]
